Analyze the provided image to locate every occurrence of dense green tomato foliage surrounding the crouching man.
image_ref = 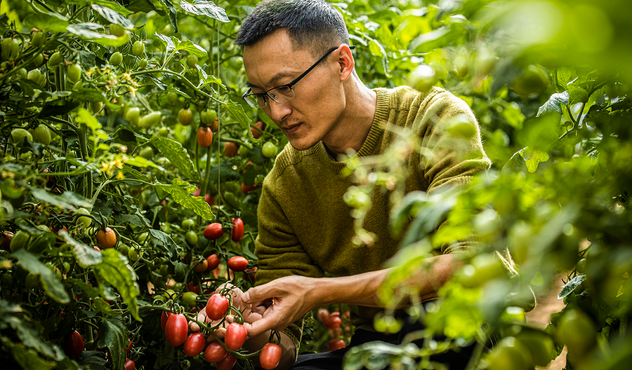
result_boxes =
[0,0,632,370]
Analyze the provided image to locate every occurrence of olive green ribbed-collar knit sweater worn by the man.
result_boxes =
[255,87,490,348]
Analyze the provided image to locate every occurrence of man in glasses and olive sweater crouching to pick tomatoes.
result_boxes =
[230,0,490,369]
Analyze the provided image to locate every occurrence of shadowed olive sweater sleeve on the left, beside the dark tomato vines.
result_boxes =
[255,175,324,355]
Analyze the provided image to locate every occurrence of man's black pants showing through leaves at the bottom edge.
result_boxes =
[292,320,474,370]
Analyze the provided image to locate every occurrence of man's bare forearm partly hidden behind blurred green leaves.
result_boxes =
[315,254,459,307]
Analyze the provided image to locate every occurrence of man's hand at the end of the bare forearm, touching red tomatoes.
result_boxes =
[241,276,321,337]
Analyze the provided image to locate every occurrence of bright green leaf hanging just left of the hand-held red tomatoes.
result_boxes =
[95,248,142,322]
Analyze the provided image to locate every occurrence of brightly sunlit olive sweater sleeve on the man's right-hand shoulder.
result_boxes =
[416,91,491,254]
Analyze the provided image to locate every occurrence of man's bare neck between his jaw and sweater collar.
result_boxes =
[323,77,377,157]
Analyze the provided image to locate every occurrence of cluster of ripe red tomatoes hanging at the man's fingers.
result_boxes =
[160,293,282,370]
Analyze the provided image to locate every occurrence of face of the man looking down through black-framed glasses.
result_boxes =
[243,30,345,150]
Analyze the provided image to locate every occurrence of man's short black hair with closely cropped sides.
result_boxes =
[234,0,349,57]
